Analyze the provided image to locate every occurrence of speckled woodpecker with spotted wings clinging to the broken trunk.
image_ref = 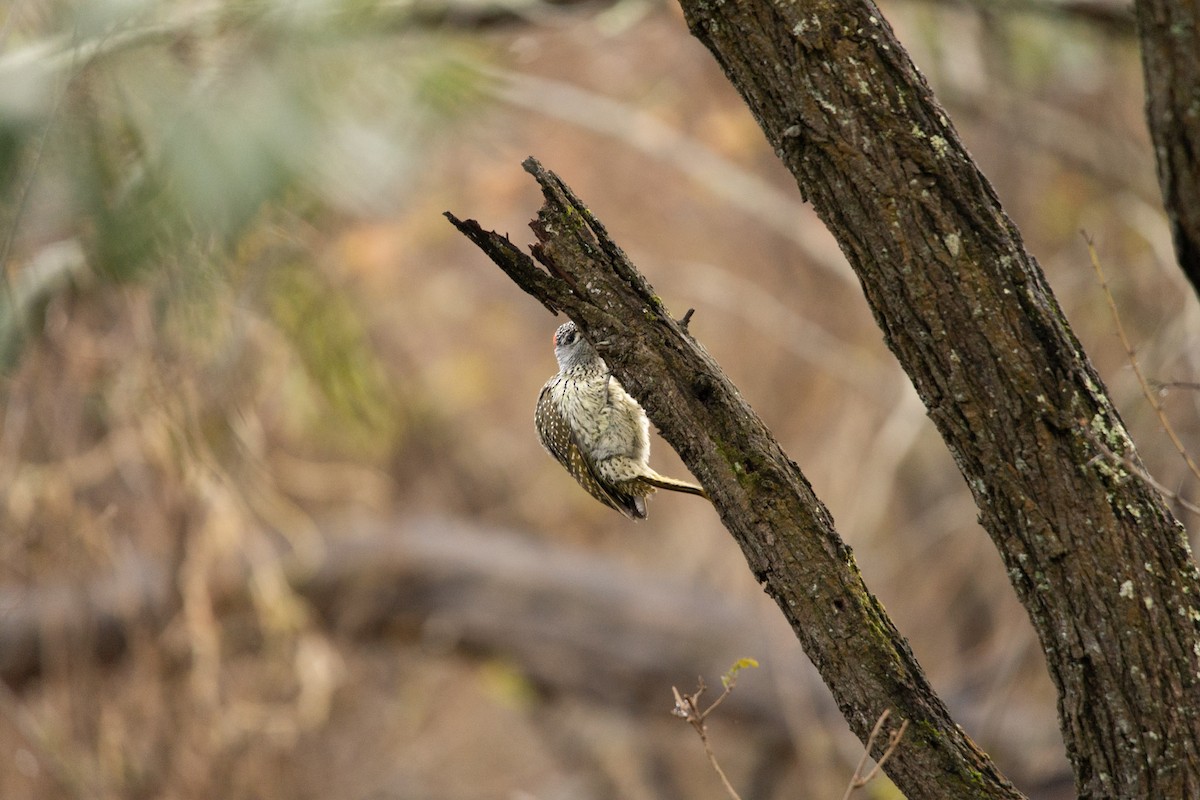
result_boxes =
[534,321,708,519]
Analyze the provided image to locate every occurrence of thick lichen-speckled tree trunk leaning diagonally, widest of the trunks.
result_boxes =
[682,0,1200,798]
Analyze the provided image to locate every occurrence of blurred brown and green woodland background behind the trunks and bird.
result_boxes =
[0,0,1200,800]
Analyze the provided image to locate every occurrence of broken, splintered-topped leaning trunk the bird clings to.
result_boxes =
[446,158,1021,800]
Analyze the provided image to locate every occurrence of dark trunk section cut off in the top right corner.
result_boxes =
[1136,0,1200,294]
